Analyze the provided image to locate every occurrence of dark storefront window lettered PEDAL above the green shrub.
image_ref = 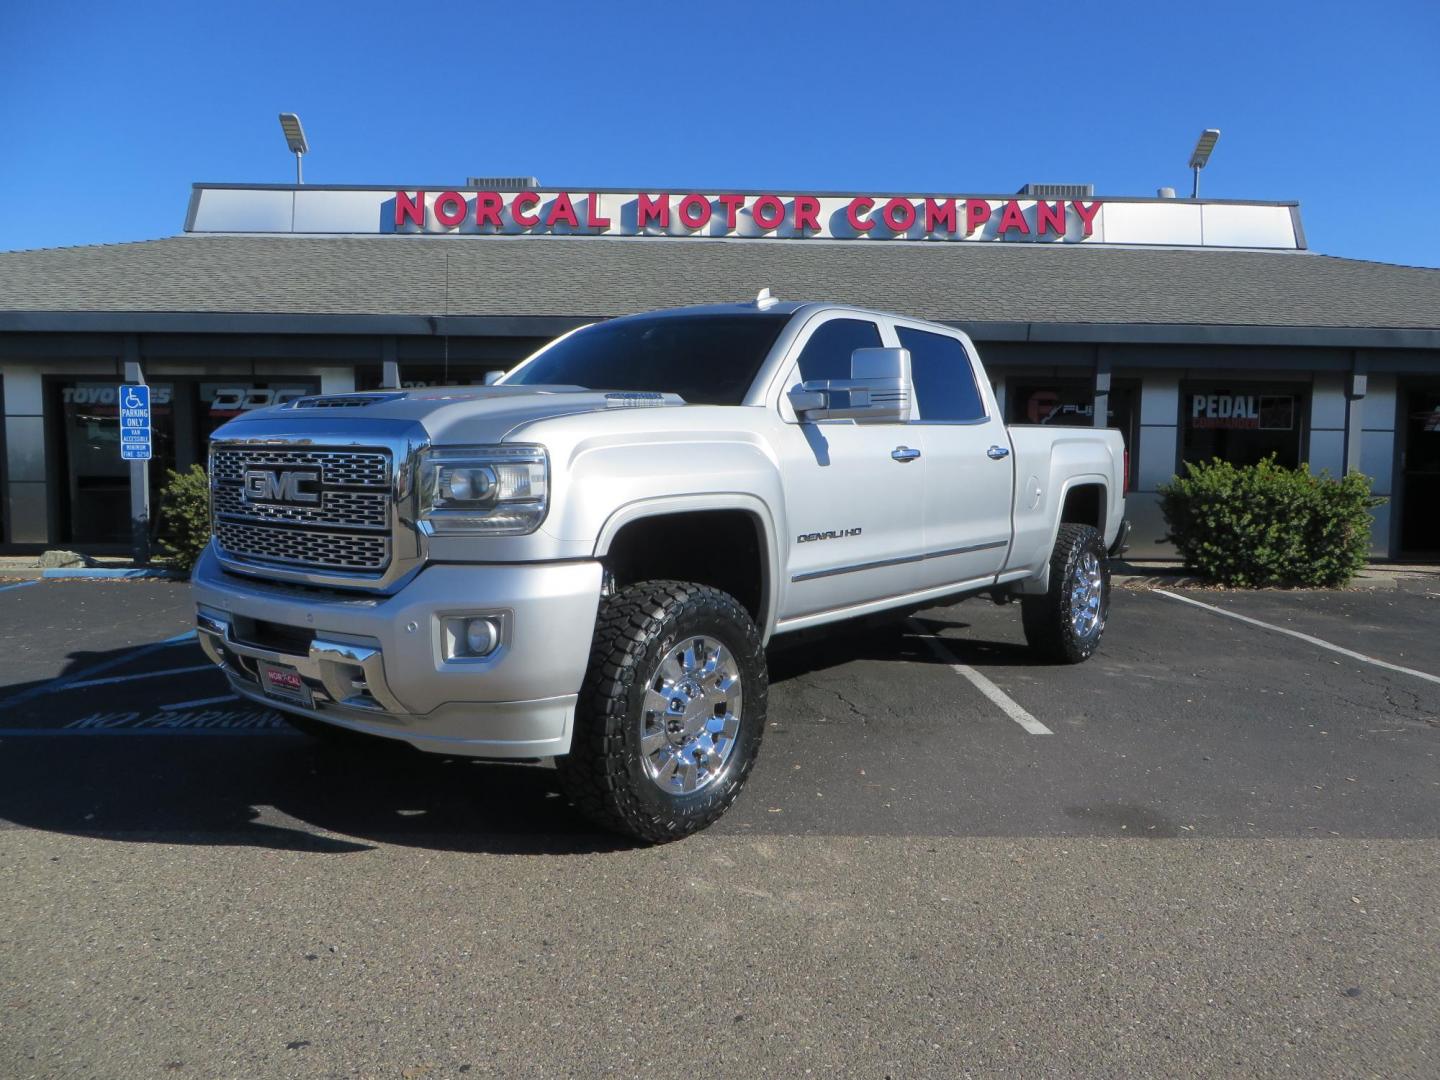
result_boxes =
[1181,383,1306,468]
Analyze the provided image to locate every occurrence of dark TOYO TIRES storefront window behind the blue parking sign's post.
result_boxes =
[53,379,176,544]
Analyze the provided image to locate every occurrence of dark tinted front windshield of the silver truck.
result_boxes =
[505,315,789,405]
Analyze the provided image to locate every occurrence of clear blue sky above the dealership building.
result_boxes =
[8,0,1440,266]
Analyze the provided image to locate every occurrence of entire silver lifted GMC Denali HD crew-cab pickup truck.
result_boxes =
[193,291,1126,841]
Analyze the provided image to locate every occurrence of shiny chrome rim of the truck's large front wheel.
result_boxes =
[639,636,744,795]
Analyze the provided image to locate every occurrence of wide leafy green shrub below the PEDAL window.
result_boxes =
[1159,454,1385,588]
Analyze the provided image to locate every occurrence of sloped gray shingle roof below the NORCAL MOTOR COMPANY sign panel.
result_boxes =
[0,236,1440,330]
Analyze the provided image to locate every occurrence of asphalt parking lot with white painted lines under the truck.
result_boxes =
[0,582,1440,1079]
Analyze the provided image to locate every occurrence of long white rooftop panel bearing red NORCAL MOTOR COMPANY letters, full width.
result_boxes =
[184,184,1305,251]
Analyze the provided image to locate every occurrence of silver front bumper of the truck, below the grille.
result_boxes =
[192,550,600,759]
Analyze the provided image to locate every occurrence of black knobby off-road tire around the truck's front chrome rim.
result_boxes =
[556,582,769,844]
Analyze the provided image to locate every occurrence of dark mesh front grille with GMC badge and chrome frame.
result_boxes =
[210,445,393,575]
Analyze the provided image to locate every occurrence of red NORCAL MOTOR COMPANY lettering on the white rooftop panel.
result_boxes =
[389,190,1102,240]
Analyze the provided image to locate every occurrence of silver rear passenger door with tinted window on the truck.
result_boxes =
[896,321,1015,586]
